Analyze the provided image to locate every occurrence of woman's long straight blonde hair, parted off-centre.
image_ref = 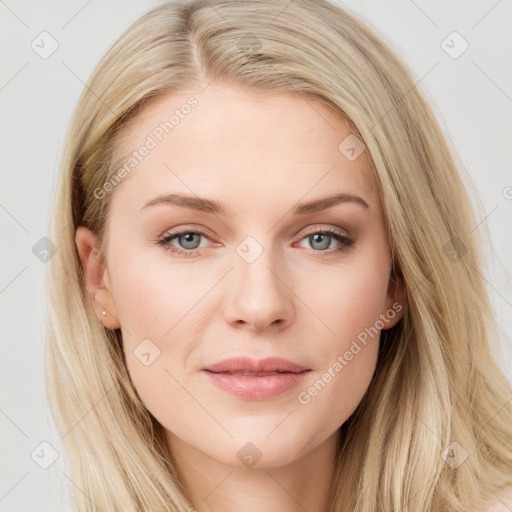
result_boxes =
[46,0,512,512]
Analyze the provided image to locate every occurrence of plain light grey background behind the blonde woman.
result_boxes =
[0,0,512,512]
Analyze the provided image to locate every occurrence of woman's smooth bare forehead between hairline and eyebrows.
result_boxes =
[109,82,378,212]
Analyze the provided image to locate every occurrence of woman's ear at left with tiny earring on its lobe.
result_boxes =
[75,226,120,329]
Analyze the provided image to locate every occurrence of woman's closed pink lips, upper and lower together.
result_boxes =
[202,357,311,400]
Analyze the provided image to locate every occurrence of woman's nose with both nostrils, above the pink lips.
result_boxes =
[224,243,295,332]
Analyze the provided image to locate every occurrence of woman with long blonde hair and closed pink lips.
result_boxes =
[47,0,512,512]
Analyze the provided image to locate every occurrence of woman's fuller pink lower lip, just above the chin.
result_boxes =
[203,370,311,400]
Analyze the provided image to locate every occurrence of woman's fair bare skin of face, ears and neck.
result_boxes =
[76,82,405,512]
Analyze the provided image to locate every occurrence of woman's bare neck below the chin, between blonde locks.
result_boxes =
[167,431,339,512]
